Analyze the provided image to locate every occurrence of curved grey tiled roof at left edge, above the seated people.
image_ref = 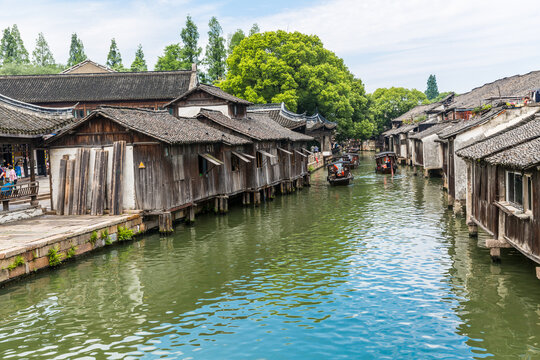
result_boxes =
[0,95,74,137]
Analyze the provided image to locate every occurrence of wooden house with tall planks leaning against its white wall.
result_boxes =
[48,107,250,221]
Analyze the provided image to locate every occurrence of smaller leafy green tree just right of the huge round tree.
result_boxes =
[370,87,429,134]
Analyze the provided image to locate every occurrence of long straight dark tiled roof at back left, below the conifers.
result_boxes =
[0,71,192,103]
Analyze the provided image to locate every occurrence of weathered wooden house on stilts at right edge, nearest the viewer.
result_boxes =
[457,115,540,276]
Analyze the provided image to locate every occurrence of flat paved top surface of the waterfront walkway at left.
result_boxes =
[0,214,141,259]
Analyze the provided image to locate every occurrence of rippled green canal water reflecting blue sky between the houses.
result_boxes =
[0,155,540,359]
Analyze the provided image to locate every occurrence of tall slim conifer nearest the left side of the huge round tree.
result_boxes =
[204,16,227,83]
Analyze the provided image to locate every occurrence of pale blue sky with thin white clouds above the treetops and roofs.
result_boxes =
[0,0,540,93]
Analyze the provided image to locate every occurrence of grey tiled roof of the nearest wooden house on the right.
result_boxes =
[456,117,540,160]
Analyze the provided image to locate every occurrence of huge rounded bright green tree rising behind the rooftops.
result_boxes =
[218,30,374,138]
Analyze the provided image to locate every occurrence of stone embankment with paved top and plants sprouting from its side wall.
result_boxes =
[0,213,145,284]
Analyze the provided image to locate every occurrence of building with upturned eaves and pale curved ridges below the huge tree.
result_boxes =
[248,103,337,151]
